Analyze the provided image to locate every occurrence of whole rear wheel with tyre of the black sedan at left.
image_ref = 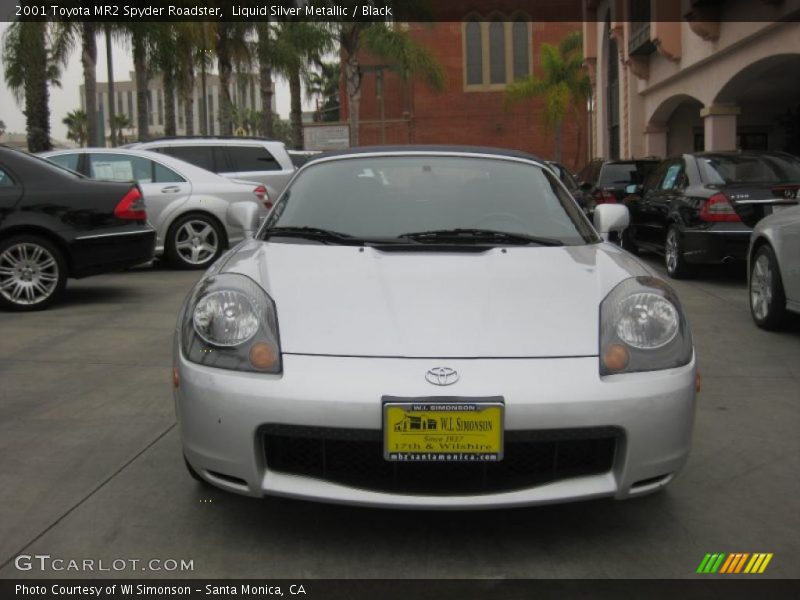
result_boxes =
[0,235,67,311]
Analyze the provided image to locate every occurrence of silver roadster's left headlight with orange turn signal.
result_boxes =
[181,273,281,373]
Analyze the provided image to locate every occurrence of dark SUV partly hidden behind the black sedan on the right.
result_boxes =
[577,158,659,214]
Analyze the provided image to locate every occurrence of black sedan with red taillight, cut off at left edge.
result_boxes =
[0,146,156,311]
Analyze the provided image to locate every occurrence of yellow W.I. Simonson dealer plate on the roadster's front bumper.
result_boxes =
[383,399,503,461]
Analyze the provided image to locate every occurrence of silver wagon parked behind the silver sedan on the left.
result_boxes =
[129,137,296,198]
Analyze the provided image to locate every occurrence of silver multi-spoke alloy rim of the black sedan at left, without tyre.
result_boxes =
[0,242,59,306]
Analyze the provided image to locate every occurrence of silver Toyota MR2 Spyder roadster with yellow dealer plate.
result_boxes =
[173,146,695,509]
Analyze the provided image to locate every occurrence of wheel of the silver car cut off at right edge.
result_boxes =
[749,246,786,330]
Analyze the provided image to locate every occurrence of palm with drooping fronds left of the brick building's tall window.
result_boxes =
[337,21,445,146]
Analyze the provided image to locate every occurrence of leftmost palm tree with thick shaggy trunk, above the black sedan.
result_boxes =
[3,21,60,152]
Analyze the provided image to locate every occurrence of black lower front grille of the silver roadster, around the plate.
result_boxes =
[262,425,622,495]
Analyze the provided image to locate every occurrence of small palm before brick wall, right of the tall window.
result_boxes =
[506,31,591,164]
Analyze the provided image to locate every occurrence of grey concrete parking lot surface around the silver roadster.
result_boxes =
[0,259,800,578]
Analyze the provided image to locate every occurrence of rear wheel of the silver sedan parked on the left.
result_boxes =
[165,215,224,269]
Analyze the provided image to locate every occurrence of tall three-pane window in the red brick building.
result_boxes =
[462,16,532,91]
